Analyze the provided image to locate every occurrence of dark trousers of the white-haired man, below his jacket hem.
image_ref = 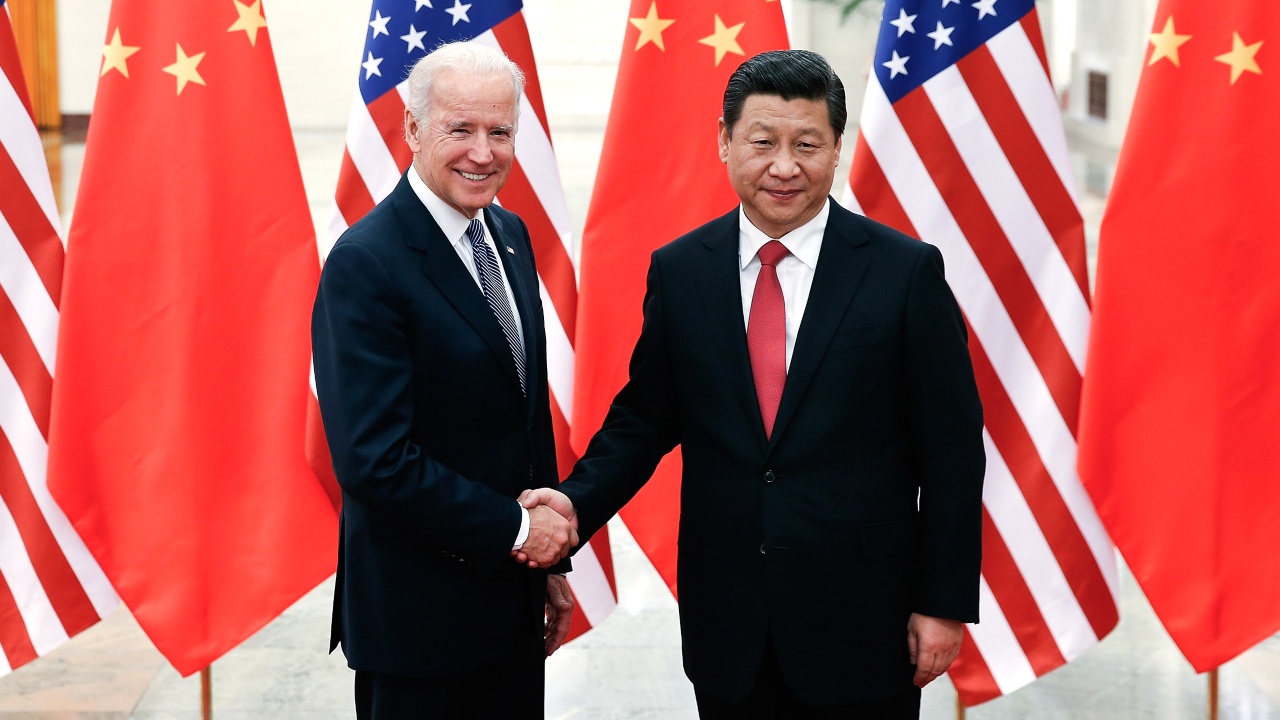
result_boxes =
[356,621,547,720]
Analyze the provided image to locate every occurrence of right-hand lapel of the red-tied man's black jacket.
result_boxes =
[769,201,873,451]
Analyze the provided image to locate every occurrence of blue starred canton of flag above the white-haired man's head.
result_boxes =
[360,0,522,105]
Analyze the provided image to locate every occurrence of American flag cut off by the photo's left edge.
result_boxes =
[0,0,118,674]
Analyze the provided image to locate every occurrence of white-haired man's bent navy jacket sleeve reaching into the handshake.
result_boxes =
[311,243,521,566]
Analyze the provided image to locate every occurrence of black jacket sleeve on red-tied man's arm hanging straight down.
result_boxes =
[904,243,986,623]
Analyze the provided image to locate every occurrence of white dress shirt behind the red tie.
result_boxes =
[737,199,831,370]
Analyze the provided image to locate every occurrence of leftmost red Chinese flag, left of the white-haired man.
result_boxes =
[49,0,337,675]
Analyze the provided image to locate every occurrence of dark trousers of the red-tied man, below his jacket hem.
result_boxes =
[694,634,920,720]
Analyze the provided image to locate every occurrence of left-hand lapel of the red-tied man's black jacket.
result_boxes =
[698,209,765,450]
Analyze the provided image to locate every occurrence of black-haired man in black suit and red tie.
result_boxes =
[522,50,986,720]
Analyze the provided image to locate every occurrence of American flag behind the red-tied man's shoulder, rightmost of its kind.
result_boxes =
[845,0,1119,705]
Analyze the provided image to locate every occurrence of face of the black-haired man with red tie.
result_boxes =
[719,95,840,238]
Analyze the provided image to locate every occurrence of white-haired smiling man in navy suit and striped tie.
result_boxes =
[311,42,577,720]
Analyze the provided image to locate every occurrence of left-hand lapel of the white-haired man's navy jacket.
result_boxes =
[390,177,527,392]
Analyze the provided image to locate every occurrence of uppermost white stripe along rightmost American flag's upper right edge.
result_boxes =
[987,23,1080,206]
